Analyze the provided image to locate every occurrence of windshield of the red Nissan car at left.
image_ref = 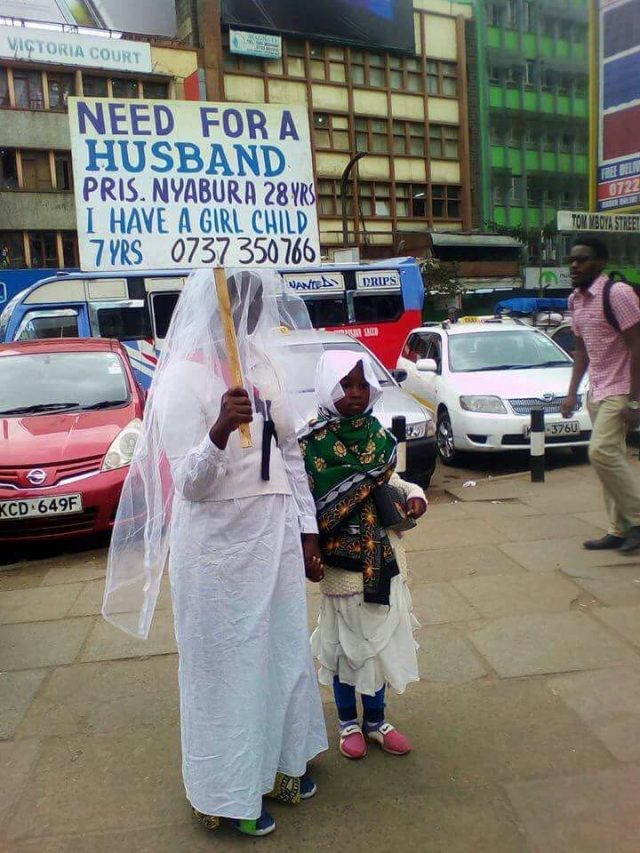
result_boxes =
[0,352,129,415]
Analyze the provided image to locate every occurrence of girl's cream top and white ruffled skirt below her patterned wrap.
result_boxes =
[311,474,425,696]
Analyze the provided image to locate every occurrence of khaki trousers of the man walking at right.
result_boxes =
[589,394,640,536]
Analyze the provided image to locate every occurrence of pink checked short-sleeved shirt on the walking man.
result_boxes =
[569,275,640,403]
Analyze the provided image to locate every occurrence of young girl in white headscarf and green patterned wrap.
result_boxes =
[301,350,427,758]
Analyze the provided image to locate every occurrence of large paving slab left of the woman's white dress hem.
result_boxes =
[5,726,186,841]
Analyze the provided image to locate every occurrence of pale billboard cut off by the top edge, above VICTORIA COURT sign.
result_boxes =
[0,0,176,37]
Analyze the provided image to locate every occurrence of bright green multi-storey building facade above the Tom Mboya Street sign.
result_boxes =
[467,0,589,253]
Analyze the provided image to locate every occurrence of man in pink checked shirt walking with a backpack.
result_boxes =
[562,237,640,554]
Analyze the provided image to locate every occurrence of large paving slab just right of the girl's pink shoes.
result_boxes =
[392,679,614,797]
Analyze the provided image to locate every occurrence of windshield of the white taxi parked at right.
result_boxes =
[449,329,571,373]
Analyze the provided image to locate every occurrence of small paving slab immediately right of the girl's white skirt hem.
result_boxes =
[415,627,489,684]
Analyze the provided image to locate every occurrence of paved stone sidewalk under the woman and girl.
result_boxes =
[0,463,640,853]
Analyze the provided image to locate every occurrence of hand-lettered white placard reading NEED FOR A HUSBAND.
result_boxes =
[69,98,320,271]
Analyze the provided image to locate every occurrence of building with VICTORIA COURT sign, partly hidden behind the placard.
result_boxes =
[0,21,198,269]
